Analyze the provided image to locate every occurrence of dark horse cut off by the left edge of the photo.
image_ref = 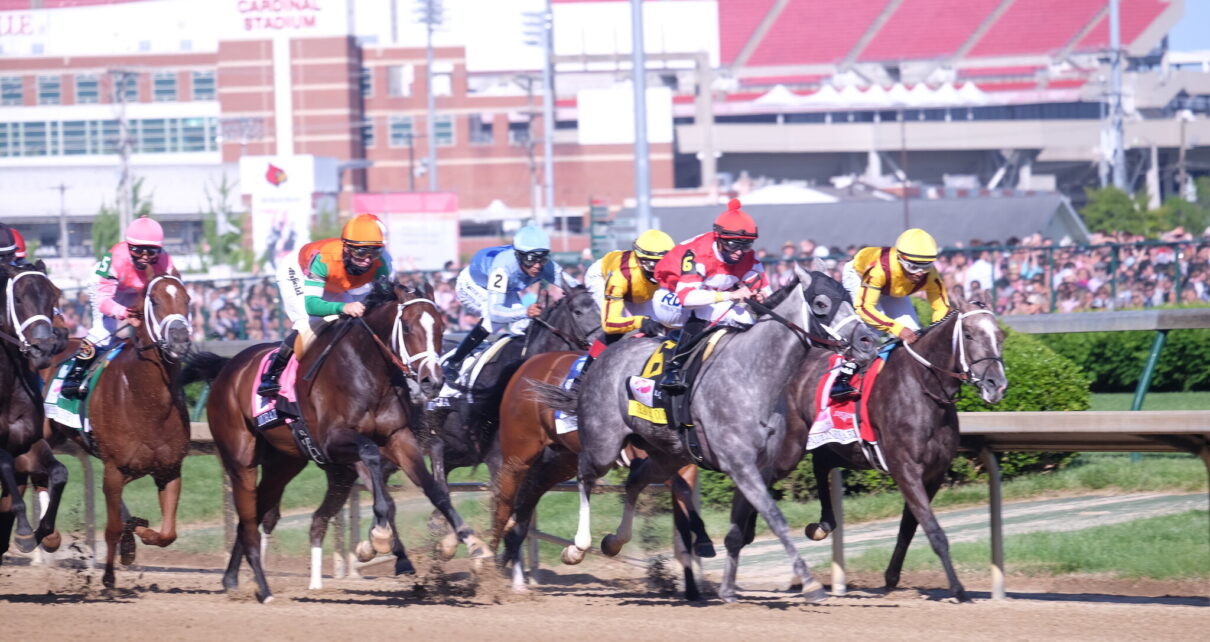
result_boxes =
[0,261,67,556]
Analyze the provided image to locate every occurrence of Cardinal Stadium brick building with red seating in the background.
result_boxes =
[0,0,1210,274]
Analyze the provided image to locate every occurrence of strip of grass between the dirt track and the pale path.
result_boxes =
[849,510,1210,579]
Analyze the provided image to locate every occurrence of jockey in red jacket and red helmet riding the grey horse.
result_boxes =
[652,198,772,393]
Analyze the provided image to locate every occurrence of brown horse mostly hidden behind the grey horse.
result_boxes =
[491,352,714,601]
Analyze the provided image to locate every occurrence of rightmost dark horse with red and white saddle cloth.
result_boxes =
[798,294,1008,602]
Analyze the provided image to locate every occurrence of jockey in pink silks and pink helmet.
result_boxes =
[59,216,179,399]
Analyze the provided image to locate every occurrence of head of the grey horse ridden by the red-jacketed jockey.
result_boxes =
[794,266,878,365]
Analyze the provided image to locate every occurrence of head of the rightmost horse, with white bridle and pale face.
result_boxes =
[951,290,1008,404]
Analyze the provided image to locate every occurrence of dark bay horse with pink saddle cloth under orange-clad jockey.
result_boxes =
[186,279,485,602]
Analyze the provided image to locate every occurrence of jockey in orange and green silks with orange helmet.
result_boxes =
[257,214,391,397]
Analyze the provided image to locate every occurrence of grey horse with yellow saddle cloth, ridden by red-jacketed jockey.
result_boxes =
[536,267,876,602]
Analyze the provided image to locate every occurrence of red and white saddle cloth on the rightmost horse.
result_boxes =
[807,354,886,450]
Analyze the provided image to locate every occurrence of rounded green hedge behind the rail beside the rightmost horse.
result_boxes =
[698,330,1091,508]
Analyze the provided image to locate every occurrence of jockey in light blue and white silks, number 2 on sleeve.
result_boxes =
[444,225,578,381]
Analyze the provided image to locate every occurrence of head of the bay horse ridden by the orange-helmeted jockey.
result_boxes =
[365,278,445,401]
